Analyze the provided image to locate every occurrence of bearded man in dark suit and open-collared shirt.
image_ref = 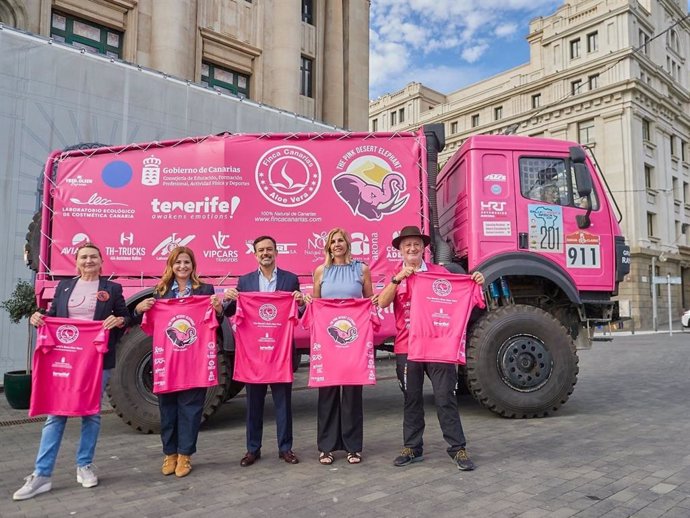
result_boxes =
[224,236,304,467]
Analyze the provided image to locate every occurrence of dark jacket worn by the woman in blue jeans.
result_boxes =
[46,277,131,369]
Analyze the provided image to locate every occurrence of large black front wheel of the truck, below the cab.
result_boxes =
[466,304,578,417]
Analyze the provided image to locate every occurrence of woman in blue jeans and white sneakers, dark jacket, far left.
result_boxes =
[13,243,130,500]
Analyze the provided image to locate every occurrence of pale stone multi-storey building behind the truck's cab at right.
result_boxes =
[369,0,690,328]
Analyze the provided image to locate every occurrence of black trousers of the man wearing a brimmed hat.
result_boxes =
[396,354,466,457]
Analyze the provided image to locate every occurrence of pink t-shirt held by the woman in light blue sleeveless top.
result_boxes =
[302,299,381,387]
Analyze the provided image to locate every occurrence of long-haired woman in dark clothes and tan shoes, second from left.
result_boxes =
[134,246,223,477]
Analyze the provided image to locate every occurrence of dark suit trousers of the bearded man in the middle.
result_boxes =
[245,383,292,453]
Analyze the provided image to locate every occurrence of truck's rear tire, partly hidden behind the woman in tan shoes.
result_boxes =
[108,327,232,433]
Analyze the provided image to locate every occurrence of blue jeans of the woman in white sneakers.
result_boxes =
[34,369,112,477]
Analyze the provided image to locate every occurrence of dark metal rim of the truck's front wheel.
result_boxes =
[497,335,553,392]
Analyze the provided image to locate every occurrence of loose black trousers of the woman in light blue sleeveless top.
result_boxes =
[316,385,364,453]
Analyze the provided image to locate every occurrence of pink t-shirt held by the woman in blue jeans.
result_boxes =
[29,317,110,416]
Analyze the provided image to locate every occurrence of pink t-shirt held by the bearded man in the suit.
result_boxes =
[232,291,299,383]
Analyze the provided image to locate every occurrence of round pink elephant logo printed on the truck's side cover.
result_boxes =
[333,156,410,221]
